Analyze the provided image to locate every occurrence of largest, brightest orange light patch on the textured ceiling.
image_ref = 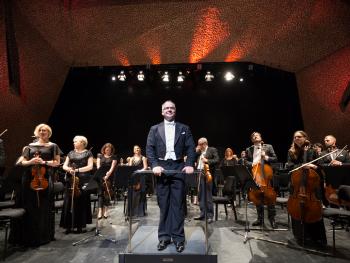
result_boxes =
[189,8,230,63]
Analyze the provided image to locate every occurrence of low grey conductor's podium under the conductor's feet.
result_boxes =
[119,226,217,263]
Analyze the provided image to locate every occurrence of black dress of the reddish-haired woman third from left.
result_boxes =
[95,153,117,208]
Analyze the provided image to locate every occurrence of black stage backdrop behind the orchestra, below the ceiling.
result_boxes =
[49,63,303,162]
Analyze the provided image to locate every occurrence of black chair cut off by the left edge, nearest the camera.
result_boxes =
[0,200,25,260]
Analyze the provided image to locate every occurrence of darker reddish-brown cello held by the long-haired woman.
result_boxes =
[287,142,322,223]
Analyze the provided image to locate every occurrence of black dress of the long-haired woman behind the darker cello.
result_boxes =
[287,149,327,246]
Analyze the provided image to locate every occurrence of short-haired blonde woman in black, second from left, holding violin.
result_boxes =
[60,135,94,234]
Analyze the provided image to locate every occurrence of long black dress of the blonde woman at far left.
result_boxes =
[9,143,61,246]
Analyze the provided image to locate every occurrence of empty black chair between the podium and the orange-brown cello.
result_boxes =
[213,176,237,221]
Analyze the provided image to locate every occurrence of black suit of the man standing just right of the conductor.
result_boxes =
[197,147,219,219]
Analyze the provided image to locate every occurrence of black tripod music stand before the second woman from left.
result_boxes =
[72,166,117,246]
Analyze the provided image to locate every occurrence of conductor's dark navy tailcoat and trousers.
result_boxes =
[146,122,196,242]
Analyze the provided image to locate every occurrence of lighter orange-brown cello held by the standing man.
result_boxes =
[248,141,277,206]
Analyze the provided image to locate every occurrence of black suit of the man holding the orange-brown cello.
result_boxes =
[246,144,277,221]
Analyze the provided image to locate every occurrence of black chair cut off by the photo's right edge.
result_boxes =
[323,185,350,254]
